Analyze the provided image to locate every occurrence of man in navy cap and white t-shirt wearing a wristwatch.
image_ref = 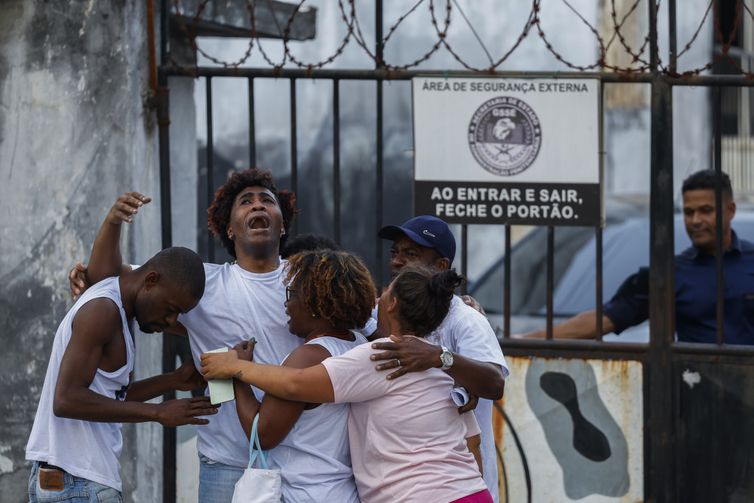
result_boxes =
[372,215,508,501]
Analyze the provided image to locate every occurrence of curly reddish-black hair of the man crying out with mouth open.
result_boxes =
[207,168,296,258]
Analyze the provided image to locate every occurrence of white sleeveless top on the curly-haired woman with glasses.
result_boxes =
[268,332,367,503]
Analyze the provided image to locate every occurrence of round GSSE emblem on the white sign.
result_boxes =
[469,96,542,176]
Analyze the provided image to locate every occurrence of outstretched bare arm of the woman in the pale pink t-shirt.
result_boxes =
[202,351,334,403]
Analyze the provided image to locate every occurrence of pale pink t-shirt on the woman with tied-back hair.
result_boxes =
[322,339,486,503]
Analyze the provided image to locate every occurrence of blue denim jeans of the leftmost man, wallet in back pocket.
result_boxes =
[29,461,123,503]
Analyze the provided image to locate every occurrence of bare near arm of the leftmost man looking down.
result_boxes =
[53,299,217,426]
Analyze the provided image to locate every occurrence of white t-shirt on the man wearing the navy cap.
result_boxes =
[426,295,509,501]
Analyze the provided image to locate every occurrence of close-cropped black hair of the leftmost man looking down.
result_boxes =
[140,246,205,300]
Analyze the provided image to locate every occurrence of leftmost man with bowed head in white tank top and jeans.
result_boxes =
[26,248,216,503]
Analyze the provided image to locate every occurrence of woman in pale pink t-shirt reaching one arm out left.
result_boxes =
[202,267,492,503]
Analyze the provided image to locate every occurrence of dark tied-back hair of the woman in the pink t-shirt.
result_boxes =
[390,264,463,337]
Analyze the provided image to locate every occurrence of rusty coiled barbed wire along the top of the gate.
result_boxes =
[170,0,754,78]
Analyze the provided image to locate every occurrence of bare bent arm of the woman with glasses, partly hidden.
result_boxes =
[233,344,330,450]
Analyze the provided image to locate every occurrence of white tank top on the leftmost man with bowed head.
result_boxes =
[26,277,134,491]
